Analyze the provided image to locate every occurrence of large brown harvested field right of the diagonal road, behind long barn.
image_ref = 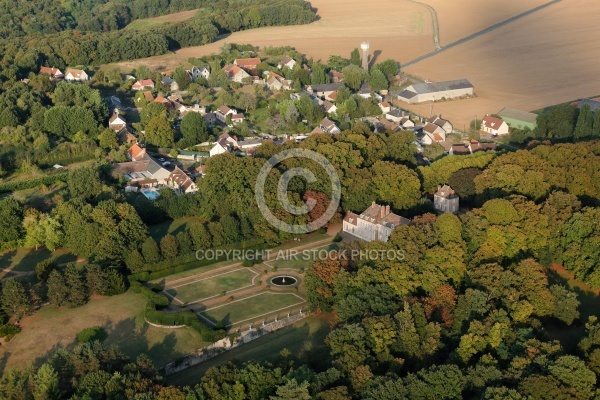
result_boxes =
[399,0,600,129]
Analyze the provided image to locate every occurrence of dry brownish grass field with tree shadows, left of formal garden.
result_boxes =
[0,291,207,373]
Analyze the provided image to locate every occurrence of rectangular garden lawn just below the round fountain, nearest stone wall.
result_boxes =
[201,292,304,326]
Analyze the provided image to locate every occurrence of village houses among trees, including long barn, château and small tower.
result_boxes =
[39,42,536,212]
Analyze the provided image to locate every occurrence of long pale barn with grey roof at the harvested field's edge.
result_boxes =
[396,79,474,104]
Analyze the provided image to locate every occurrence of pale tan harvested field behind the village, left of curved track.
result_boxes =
[112,0,434,69]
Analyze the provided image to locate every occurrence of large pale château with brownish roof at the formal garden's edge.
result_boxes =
[342,202,410,242]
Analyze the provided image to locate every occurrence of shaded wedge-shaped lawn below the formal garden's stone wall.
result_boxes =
[167,314,331,386]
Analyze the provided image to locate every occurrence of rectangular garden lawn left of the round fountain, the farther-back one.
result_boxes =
[166,267,257,303]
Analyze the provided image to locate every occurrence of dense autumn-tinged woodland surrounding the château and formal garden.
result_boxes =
[0,140,600,399]
